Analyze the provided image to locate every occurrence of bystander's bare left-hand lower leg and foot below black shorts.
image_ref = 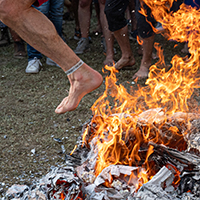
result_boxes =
[114,25,135,70]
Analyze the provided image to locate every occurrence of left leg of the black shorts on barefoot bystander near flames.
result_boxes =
[104,0,129,32]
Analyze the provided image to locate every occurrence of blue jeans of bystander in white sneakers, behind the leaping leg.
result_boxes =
[27,0,64,61]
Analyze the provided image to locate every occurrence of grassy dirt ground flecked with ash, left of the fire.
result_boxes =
[0,5,194,195]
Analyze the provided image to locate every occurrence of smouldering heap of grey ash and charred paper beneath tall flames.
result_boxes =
[4,108,200,200]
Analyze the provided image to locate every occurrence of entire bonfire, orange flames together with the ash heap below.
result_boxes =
[3,0,200,200]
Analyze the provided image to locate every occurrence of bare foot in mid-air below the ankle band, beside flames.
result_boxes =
[55,63,103,114]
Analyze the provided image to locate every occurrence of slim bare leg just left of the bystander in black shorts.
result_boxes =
[99,0,114,66]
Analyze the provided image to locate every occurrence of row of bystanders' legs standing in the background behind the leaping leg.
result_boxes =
[0,0,153,78]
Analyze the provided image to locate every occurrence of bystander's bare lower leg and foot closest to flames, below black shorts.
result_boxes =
[133,35,154,79]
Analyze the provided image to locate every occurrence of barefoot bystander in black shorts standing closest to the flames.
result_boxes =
[105,0,156,79]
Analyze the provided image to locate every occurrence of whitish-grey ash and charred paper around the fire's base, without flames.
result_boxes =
[5,108,200,200]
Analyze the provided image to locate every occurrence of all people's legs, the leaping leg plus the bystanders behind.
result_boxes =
[0,0,198,113]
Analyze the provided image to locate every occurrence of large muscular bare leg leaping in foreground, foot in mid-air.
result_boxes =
[0,0,102,113]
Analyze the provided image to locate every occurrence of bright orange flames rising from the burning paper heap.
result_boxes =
[83,0,200,191]
